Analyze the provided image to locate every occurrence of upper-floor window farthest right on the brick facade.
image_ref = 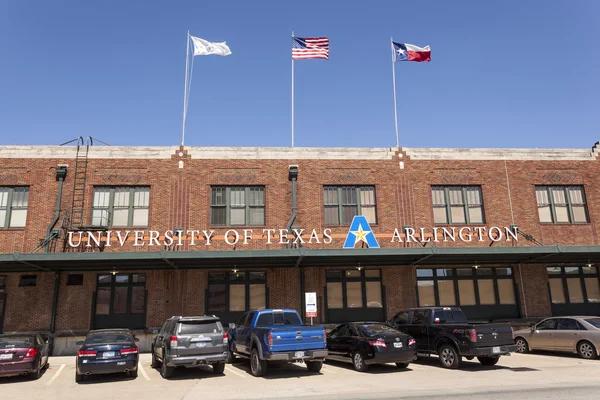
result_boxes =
[535,186,589,224]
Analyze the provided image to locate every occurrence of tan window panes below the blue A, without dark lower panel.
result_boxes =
[326,269,383,309]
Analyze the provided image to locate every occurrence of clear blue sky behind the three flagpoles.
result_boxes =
[0,0,600,148]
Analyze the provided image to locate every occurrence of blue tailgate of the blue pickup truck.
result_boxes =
[268,325,327,352]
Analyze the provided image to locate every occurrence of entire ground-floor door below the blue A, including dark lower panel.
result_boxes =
[325,269,386,323]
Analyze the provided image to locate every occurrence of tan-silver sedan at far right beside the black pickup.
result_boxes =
[513,316,600,359]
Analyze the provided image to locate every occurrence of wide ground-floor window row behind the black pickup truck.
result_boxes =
[417,267,517,307]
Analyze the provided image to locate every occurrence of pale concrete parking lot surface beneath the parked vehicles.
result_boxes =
[0,353,600,400]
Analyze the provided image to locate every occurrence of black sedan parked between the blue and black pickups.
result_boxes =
[327,322,417,372]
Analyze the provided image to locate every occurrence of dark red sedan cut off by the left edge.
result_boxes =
[0,334,48,379]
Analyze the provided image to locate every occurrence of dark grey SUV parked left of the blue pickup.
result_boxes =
[152,316,229,378]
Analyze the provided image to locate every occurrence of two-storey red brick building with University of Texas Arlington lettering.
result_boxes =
[0,140,600,354]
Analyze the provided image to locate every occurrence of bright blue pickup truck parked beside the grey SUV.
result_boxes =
[228,310,327,376]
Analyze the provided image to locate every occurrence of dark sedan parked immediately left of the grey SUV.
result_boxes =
[75,329,138,382]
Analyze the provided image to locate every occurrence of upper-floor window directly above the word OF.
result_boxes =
[210,186,265,226]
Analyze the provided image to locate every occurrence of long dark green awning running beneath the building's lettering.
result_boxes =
[0,245,600,272]
